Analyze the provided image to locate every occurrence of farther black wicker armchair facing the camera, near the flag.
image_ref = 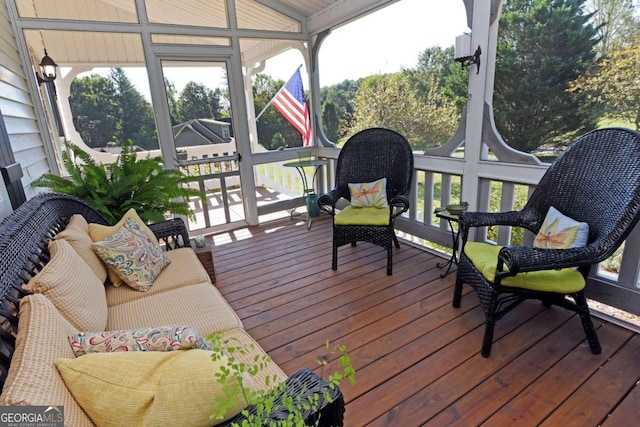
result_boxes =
[318,128,413,274]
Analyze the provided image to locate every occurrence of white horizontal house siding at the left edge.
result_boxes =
[0,1,50,198]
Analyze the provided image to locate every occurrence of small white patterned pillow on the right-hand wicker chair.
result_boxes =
[533,206,589,249]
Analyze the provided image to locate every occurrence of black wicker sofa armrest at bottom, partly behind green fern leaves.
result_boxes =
[221,369,344,427]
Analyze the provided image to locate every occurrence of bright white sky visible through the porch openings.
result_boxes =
[81,0,470,99]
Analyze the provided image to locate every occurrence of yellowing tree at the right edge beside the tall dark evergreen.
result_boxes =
[570,38,640,130]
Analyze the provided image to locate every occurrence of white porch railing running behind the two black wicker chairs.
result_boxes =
[312,150,640,315]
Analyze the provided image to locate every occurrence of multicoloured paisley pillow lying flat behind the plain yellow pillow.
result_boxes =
[69,326,211,357]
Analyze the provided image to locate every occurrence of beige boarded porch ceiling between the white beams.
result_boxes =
[16,0,398,67]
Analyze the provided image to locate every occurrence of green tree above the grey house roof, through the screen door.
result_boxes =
[177,82,222,122]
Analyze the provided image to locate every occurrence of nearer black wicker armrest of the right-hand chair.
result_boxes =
[498,244,606,276]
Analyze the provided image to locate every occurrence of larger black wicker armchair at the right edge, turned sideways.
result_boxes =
[453,128,640,357]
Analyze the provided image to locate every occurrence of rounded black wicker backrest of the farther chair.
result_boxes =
[335,128,413,200]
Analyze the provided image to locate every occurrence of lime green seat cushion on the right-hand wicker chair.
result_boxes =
[464,242,585,294]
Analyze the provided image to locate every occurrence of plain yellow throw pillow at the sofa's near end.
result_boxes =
[55,349,253,427]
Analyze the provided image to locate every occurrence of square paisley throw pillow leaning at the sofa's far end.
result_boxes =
[91,218,171,292]
